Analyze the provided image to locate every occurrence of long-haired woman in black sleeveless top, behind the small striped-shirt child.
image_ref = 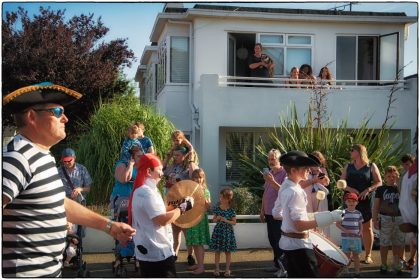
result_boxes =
[340,144,382,264]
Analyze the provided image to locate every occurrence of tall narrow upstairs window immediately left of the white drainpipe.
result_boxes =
[170,37,190,83]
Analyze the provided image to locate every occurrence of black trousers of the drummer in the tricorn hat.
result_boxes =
[284,249,319,278]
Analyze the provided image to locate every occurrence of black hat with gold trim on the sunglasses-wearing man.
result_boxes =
[3,82,83,113]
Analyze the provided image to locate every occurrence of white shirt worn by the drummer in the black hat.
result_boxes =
[273,178,313,250]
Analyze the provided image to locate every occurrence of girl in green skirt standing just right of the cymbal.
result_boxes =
[186,168,211,275]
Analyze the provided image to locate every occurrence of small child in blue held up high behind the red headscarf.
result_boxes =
[121,122,155,161]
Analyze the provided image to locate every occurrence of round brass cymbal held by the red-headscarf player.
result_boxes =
[165,180,206,228]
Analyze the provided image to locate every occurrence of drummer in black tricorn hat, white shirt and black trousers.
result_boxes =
[273,151,343,278]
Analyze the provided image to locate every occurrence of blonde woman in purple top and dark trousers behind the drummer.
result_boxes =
[260,149,286,276]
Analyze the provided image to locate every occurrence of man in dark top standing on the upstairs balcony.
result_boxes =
[248,43,275,83]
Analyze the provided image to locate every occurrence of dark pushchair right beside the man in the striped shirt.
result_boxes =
[63,225,90,278]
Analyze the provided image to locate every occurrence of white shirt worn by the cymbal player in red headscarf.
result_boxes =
[132,178,175,262]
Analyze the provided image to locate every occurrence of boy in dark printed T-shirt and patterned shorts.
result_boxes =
[372,166,405,275]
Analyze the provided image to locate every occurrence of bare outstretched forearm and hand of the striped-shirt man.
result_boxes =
[64,198,136,244]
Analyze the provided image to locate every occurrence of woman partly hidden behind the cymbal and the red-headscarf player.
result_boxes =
[163,145,198,265]
